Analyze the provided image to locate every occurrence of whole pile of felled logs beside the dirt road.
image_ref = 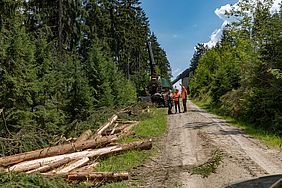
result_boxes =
[0,115,152,181]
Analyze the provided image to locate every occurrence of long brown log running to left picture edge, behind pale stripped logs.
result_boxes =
[0,135,117,166]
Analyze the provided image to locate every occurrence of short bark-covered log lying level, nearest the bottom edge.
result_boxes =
[67,172,128,181]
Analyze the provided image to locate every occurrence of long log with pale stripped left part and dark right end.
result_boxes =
[9,139,152,172]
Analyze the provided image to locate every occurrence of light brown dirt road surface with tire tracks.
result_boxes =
[132,102,282,188]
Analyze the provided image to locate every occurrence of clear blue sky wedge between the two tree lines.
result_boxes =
[141,0,237,77]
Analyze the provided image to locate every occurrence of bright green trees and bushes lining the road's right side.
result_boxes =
[190,1,282,132]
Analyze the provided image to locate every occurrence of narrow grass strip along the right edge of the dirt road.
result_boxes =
[193,100,282,151]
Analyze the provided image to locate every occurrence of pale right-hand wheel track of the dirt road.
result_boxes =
[194,102,282,176]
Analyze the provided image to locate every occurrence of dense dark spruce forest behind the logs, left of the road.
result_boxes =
[0,0,171,155]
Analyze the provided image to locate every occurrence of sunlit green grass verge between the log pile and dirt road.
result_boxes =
[96,108,167,188]
